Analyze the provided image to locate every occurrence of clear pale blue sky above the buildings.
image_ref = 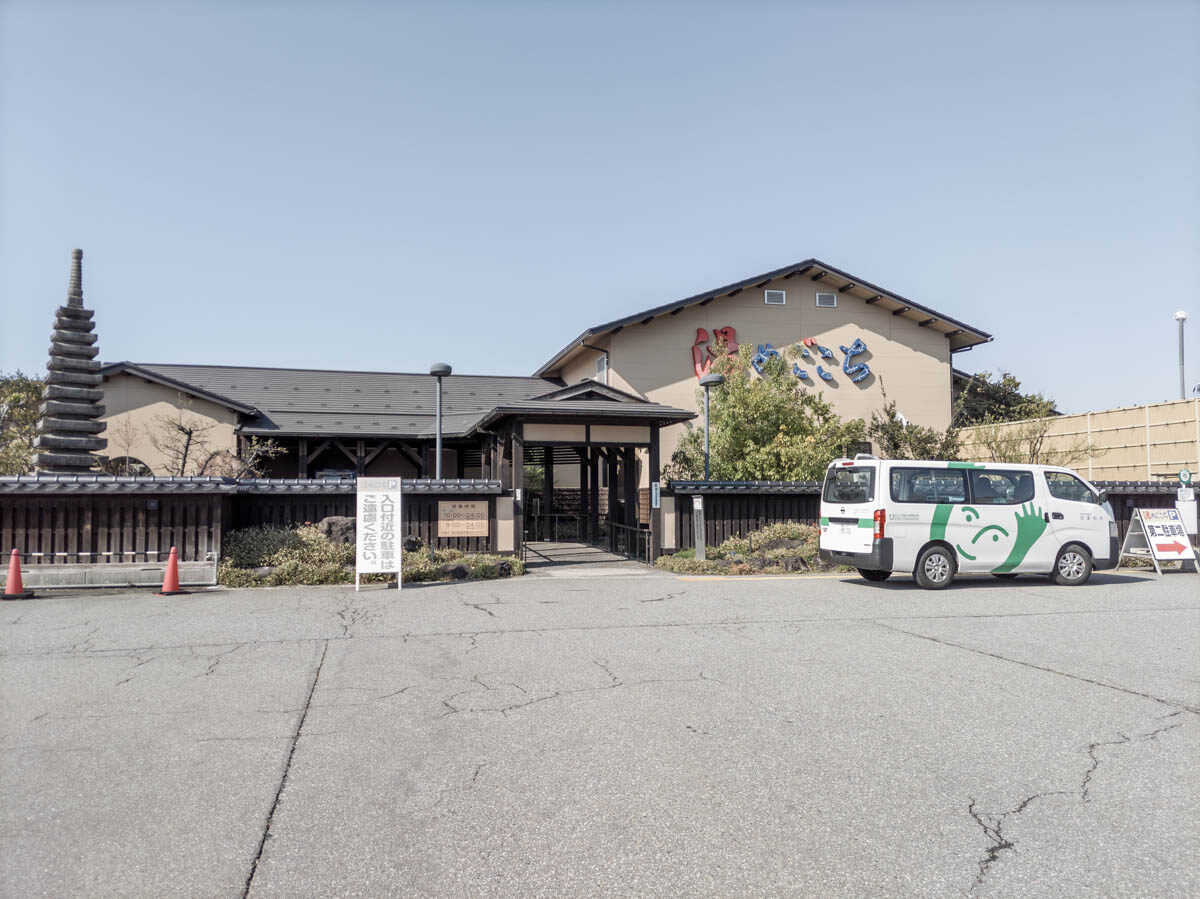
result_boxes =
[0,0,1200,412]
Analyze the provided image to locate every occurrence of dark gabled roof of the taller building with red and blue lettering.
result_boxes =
[534,259,991,377]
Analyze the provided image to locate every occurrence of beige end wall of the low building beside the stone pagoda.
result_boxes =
[103,374,238,474]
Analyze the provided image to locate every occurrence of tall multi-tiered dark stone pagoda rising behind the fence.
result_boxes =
[32,250,108,474]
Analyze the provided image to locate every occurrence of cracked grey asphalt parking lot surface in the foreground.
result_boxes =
[0,571,1200,897]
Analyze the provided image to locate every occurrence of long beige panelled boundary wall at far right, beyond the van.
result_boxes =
[962,400,1200,481]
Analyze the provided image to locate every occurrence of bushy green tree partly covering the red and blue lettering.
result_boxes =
[666,346,865,480]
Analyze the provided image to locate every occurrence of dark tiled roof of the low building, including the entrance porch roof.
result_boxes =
[102,362,694,438]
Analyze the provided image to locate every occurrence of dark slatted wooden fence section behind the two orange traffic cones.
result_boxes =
[0,495,221,565]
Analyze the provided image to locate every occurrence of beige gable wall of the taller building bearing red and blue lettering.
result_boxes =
[549,276,950,487]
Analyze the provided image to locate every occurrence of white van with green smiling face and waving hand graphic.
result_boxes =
[821,455,1117,589]
